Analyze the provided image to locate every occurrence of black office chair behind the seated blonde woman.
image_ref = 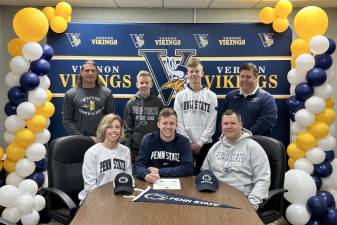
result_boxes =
[45,135,95,224]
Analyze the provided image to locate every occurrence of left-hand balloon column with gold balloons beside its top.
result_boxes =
[0,2,71,225]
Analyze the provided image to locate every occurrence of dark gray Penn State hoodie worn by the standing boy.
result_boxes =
[123,92,164,153]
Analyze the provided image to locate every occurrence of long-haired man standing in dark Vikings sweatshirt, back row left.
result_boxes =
[62,60,113,142]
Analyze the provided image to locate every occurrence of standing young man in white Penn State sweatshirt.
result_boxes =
[174,58,218,174]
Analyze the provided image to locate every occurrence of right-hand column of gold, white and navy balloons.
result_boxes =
[284,6,337,225]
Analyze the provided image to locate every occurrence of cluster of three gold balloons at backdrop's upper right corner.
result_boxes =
[259,0,293,33]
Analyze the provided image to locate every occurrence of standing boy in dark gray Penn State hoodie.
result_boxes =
[123,70,164,163]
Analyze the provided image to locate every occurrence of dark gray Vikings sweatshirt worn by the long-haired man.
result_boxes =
[62,86,113,136]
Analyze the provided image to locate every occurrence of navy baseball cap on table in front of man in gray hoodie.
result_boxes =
[195,170,219,192]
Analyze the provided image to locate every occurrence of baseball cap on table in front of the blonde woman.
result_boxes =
[113,172,135,194]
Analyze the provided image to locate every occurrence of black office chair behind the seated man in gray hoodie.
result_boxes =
[251,135,287,224]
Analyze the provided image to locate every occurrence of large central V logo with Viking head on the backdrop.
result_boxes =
[138,49,197,106]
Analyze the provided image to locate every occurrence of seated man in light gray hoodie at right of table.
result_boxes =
[201,110,270,209]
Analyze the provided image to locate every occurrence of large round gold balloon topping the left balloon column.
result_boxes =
[13,7,49,42]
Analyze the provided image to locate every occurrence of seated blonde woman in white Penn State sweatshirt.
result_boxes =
[78,114,132,201]
